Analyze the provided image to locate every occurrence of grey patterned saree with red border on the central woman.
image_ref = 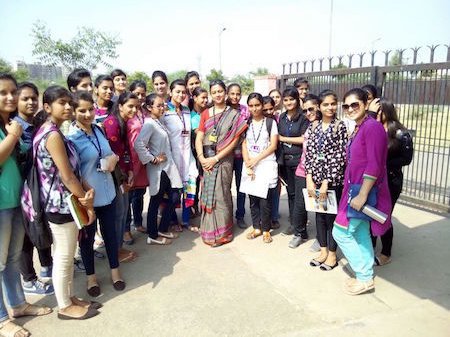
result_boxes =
[199,108,247,246]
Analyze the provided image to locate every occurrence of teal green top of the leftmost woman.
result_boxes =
[0,129,23,210]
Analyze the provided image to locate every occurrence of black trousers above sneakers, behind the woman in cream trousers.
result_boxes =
[19,233,53,282]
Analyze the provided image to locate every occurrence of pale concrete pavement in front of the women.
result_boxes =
[22,194,450,337]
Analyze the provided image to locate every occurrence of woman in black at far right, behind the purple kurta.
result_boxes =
[372,98,413,266]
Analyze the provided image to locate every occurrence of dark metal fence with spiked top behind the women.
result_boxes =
[278,46,450,212]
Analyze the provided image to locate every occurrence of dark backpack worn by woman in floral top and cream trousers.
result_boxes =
[22,130,57,249]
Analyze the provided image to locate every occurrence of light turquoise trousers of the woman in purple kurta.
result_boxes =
[333,219,374,282]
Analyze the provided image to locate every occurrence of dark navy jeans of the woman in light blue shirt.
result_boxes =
[80,201,119,275]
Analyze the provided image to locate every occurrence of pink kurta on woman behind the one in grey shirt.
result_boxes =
[127,114,148,188]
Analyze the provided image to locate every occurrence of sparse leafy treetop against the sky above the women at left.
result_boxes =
[32,21,121,70]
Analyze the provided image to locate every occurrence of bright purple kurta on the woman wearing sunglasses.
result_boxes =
[334,117,392,236]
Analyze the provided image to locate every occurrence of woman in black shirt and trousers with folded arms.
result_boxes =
[278,87,309,235]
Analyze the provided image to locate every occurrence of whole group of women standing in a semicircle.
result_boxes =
[0,69,414,336]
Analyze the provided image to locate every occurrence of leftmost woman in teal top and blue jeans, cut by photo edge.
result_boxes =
[0,73,52,336]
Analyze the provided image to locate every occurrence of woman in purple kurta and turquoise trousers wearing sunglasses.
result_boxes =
[333,88,392,295]
